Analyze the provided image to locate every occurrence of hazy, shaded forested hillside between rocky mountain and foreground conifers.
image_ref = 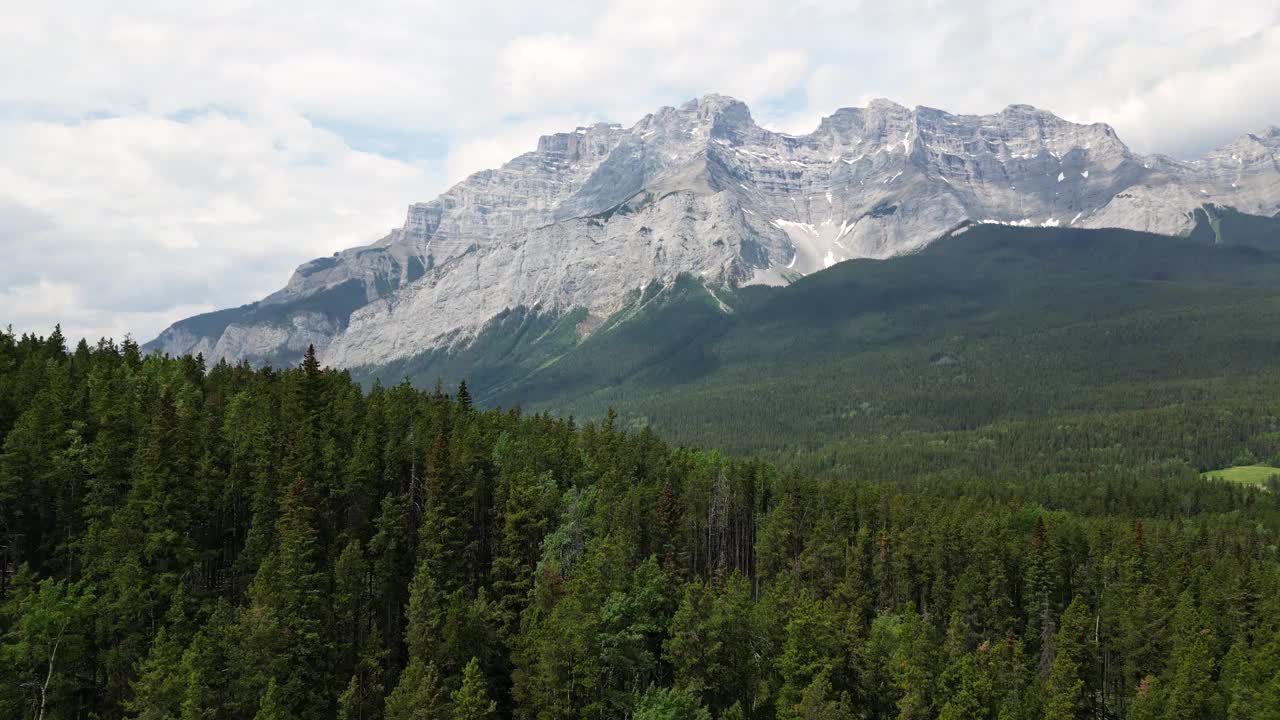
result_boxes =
[355,221,1280,486]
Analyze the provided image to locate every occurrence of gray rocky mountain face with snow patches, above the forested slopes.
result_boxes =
[148,95,1280,366]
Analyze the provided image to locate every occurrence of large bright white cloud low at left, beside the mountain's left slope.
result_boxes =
[0,113,428,338]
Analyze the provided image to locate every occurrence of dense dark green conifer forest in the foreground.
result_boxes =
[0,326,1280,720]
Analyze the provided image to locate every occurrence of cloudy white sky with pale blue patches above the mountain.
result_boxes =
[0,0,1280,341]
